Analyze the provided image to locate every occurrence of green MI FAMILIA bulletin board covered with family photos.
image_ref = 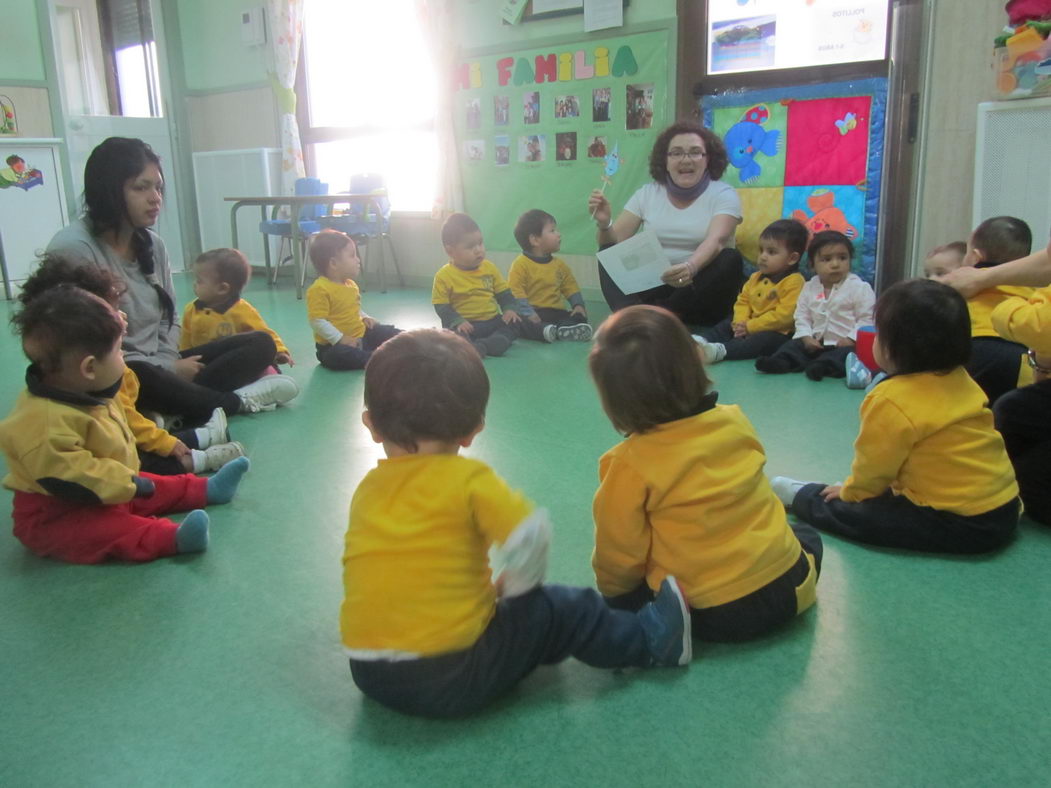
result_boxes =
[453,30,669,254]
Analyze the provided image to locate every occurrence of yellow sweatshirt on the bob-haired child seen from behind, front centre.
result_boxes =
[592,406,816,611]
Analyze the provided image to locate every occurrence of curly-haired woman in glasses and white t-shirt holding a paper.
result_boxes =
[588,121,744,326]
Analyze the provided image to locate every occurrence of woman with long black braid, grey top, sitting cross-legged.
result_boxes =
[47,137,298,422]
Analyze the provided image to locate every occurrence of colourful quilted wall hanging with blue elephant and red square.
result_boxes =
[701,78,887,283]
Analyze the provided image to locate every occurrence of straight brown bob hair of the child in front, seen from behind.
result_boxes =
[588,306,712,435]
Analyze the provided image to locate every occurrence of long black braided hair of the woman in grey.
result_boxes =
[84,137,176,327]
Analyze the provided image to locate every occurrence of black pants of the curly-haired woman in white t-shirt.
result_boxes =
[598,249,744,326]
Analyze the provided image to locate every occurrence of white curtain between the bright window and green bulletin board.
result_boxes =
[416,0,463,220]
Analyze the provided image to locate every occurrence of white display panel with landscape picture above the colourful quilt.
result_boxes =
[707,0,890,74]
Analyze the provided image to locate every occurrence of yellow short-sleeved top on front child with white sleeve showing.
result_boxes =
[339,454,533,657]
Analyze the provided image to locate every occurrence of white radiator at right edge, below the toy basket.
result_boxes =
[971,99,1051,240]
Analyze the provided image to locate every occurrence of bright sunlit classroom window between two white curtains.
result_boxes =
[302,0,438,211]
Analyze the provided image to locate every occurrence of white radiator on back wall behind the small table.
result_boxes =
[193,148,281,266]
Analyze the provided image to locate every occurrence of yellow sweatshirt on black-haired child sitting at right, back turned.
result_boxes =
[840,367,1018,516]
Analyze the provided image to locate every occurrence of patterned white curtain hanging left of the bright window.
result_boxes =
[267,0,307,194]
